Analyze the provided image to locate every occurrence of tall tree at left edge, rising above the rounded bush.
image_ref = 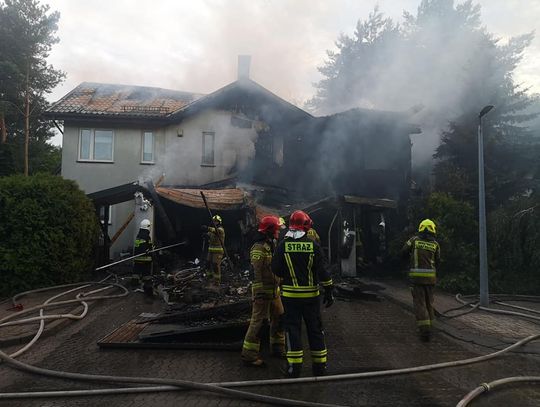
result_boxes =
[0,0,64,175]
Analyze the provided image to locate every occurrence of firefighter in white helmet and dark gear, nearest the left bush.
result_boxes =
[133,219,154,297]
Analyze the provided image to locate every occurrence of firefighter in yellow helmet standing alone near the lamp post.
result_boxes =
[402,219,441,342]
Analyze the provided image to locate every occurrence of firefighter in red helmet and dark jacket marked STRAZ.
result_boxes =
[272,211,334,377]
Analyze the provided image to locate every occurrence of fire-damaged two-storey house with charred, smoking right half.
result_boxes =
[46,61,418,270]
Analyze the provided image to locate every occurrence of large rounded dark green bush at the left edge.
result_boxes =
[0,174,99,296]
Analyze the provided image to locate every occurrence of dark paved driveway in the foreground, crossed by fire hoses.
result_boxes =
[0,294,540,407]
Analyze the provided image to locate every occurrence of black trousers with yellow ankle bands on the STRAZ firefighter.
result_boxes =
[281,297,328,375]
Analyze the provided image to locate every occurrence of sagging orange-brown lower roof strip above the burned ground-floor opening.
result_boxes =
[156,187,246,211]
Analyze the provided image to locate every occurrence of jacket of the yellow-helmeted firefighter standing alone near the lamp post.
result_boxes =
[402,233,441,284]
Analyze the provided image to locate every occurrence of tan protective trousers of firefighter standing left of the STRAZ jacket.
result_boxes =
[242,297,285,362]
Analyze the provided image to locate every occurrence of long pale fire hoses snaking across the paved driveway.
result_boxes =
[0,282,540,407]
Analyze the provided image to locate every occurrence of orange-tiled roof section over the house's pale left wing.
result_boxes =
[45,82,204,118]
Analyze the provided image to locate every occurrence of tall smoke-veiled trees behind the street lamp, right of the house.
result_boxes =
[310,0,538,206]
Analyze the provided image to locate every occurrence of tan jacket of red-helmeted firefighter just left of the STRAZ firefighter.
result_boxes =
[249,233,277,299]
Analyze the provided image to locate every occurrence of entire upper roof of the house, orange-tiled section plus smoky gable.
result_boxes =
[44,79,312,122]
